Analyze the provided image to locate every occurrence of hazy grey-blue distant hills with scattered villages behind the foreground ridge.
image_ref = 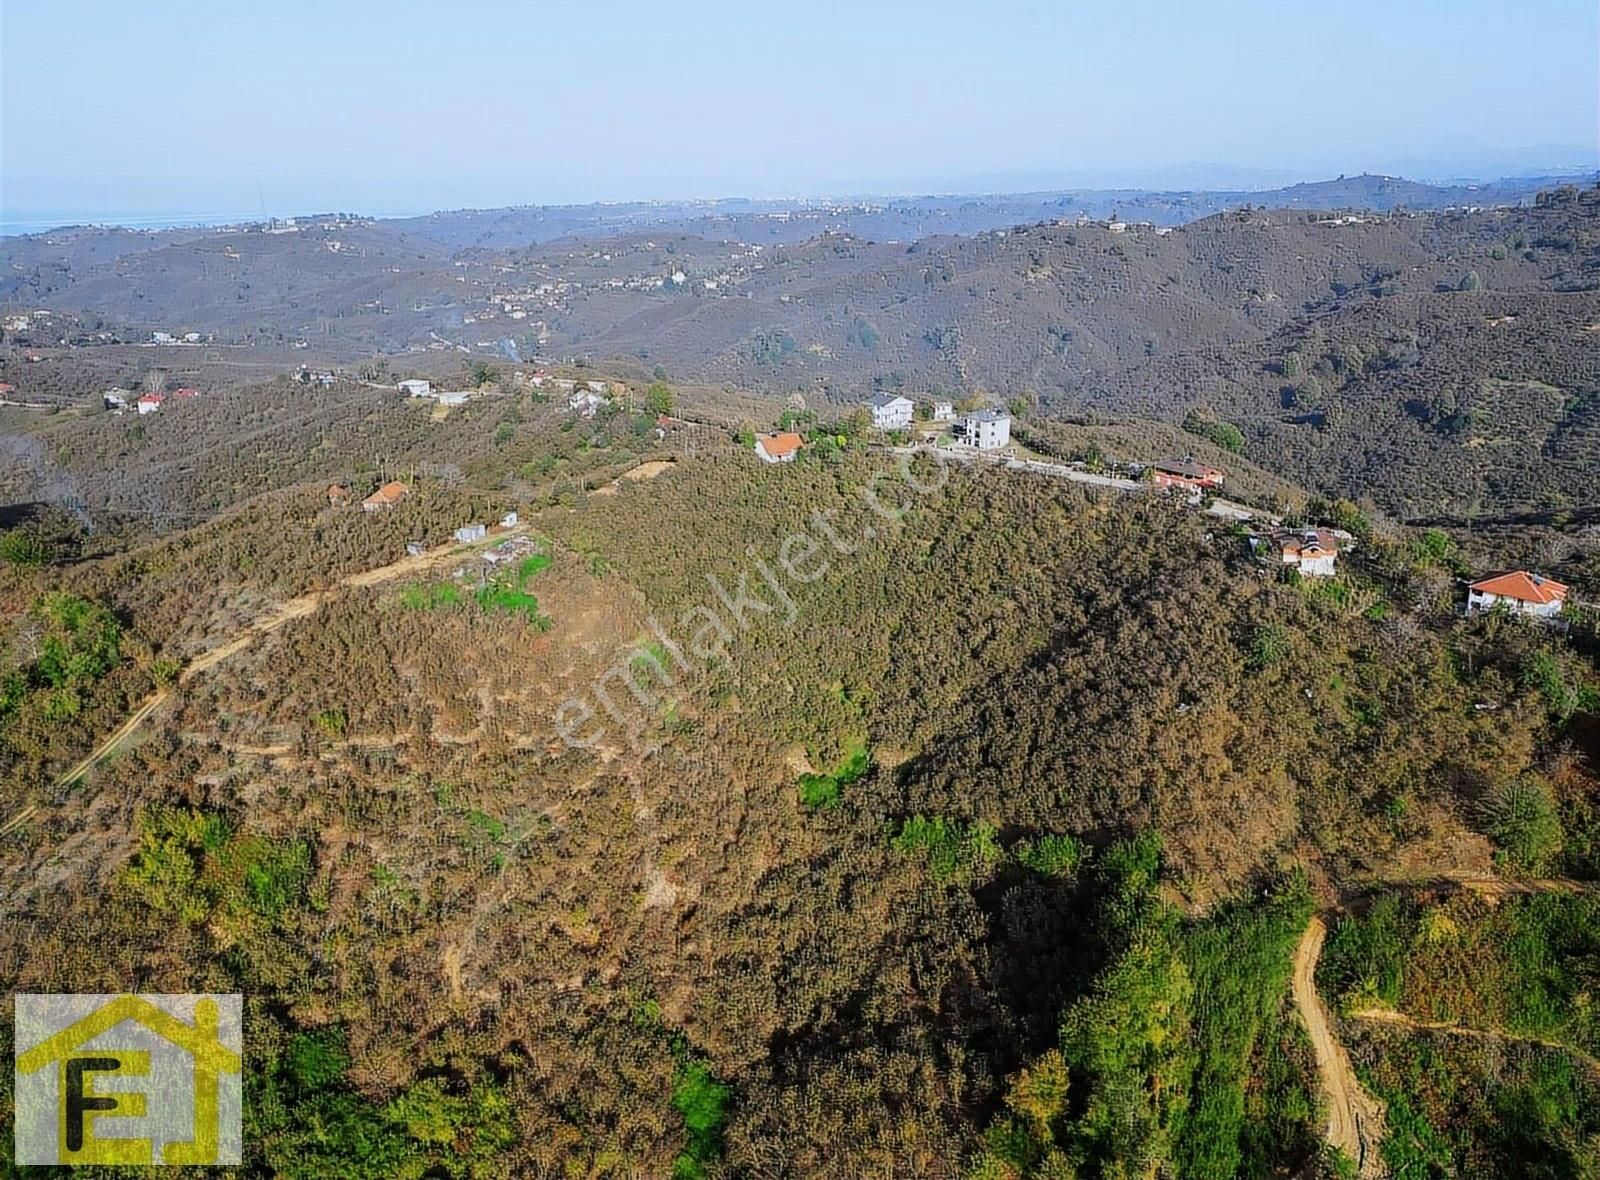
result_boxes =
[0,176,1600,515]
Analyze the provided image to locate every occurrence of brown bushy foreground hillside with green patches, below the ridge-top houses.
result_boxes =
[0,418,1600,1180]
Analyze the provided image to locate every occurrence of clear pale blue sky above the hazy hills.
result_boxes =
[0,0,1600,224]
